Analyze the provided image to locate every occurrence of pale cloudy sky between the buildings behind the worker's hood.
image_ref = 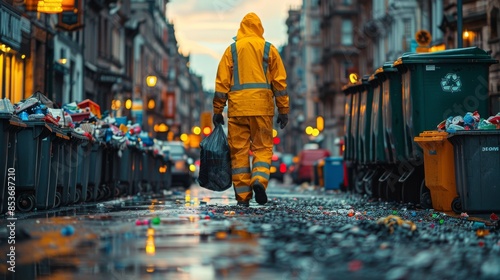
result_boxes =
[167,0,302,91]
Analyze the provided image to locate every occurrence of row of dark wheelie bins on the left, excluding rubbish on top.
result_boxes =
[0,116,172,213]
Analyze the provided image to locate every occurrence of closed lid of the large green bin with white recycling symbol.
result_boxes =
[393,47,498,67]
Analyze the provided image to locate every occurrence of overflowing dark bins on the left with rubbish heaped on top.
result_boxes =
[0,92,169,213]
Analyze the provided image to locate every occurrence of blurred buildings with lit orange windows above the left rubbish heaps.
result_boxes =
[0,0,204,139]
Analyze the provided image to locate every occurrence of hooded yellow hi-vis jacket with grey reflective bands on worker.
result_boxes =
[213,13,290,117]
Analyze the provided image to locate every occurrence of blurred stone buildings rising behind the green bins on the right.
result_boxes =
[284,0,500,154]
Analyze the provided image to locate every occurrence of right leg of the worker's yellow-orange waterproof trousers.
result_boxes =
[249,116,273,189]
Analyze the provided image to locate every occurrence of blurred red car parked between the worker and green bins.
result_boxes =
[292,149,330,184]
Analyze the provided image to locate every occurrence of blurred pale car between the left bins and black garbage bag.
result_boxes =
[162,141,194,189]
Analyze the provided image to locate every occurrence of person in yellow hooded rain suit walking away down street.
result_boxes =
[212,13,290,207]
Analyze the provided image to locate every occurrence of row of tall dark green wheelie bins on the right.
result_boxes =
[342,47,498,212]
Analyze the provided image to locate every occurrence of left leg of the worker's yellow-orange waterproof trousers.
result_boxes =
[227,117,253,201]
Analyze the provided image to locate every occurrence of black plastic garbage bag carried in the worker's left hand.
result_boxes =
[197,124,232,192]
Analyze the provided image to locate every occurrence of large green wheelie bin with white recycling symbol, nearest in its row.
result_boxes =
[393,47,498,202]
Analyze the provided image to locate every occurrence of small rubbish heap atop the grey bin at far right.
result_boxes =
[437,111,500,132]
